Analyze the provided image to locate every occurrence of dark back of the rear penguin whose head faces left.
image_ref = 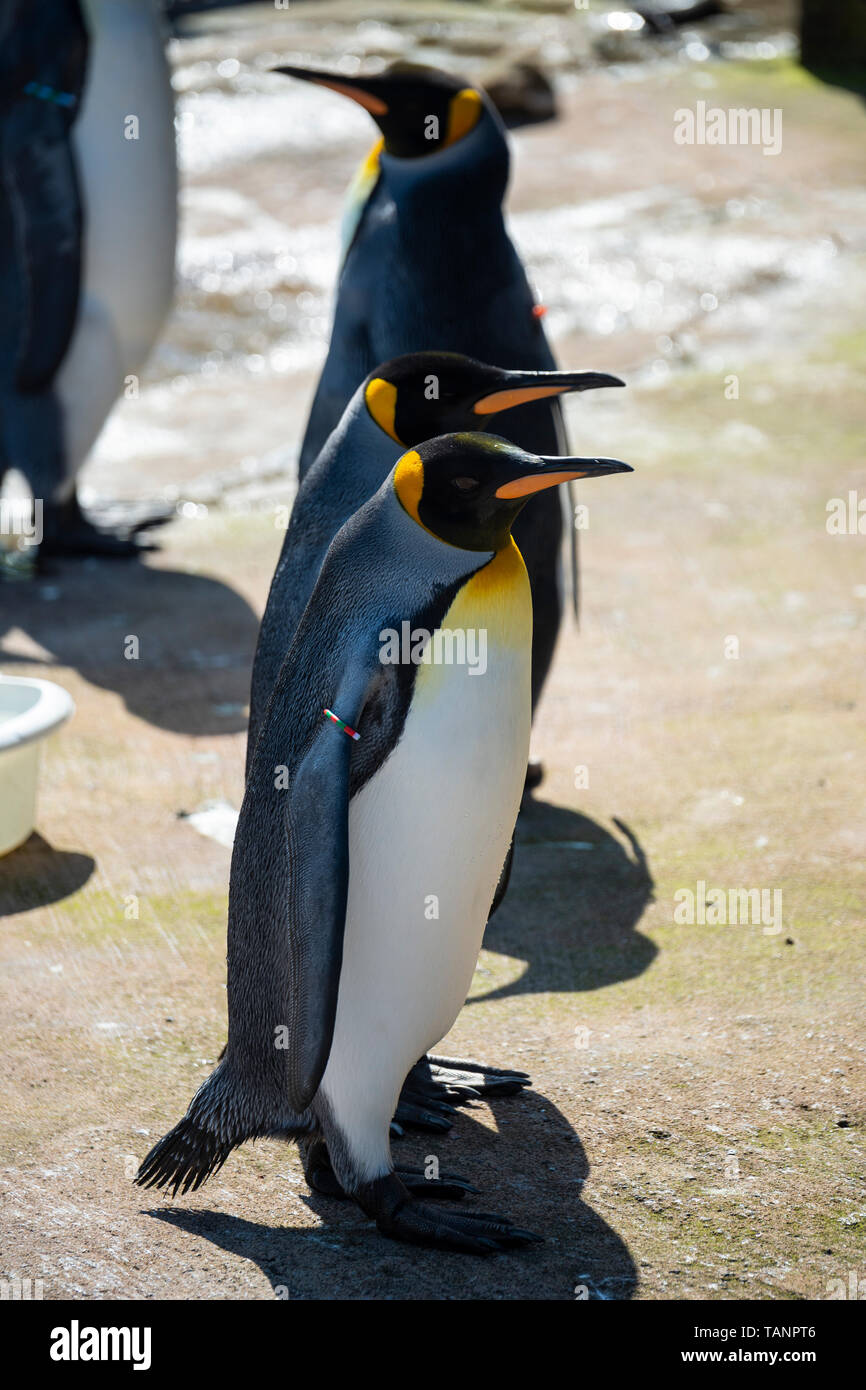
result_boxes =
[299,106,562,477]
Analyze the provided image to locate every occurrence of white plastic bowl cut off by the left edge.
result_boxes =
[0,676,75,855]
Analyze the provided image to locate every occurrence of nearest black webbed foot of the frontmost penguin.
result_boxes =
[357,1173,544,1255]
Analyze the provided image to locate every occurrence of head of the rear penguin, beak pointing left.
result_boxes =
[272,63,484,160]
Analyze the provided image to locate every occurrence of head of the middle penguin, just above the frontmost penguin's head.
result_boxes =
[364,352,623,448]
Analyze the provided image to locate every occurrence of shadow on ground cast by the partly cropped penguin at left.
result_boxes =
[0,560,259,735]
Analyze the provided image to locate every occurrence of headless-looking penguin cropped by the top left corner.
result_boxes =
[0,0,177,556]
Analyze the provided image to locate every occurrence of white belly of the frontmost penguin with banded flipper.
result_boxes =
[321,536,531,1177]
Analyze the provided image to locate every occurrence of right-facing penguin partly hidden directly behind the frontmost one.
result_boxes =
[247,353,623,769]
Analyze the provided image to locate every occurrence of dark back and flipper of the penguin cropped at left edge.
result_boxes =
[0,0,89,517]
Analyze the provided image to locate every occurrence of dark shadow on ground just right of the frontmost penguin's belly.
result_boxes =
[468,796,657,1004]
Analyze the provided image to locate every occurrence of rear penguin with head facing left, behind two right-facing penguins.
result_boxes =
[277,64,600,750]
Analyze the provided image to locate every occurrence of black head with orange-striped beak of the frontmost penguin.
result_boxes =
[392,434,632,550]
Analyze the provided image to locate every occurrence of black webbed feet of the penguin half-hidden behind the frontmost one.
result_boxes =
[392,1055,530,1134]
